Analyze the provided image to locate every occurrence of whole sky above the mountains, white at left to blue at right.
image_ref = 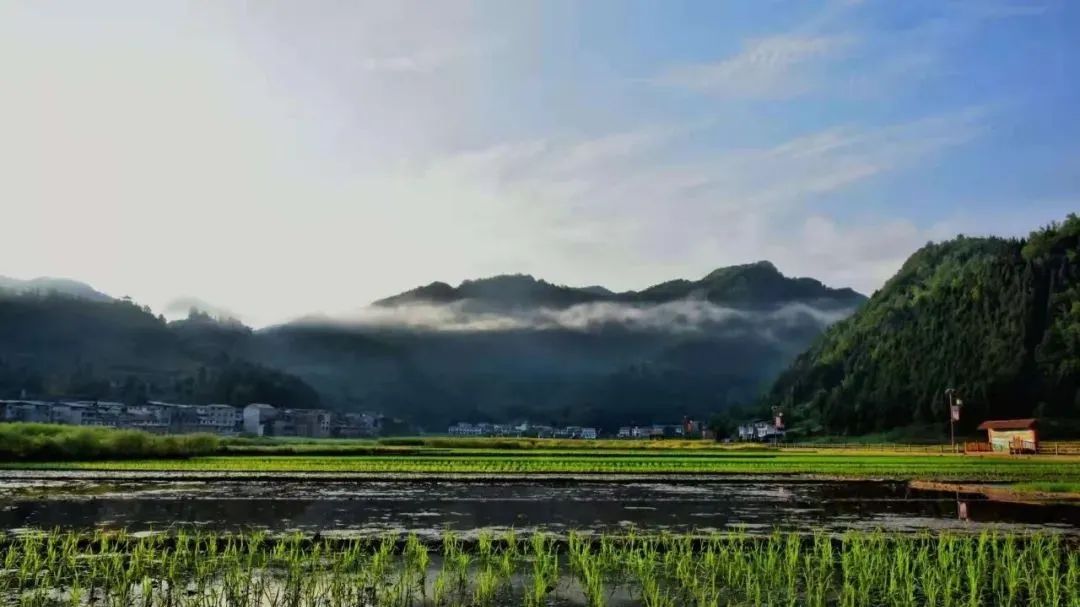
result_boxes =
[0,0,1080,326]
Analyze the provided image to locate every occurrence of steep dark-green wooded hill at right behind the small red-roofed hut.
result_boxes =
[767,215,1080,434]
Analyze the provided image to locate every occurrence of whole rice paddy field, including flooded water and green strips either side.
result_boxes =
[0,441,1080,607]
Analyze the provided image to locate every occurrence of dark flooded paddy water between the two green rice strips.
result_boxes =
[0,476,1080,535]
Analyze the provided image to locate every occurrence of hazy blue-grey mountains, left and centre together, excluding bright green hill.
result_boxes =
[0,262,863,430]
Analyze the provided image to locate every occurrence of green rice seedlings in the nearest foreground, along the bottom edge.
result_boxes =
[0,529,1080,607]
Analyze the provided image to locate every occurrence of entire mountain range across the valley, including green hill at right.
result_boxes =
[0,210,1080,435]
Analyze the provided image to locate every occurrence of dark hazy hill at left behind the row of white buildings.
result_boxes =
[0,291,320,406]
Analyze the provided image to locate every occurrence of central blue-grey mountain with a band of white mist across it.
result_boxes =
[259,262,864,428]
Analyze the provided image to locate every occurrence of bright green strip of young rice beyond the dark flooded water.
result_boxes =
[12,451,1080,483]
